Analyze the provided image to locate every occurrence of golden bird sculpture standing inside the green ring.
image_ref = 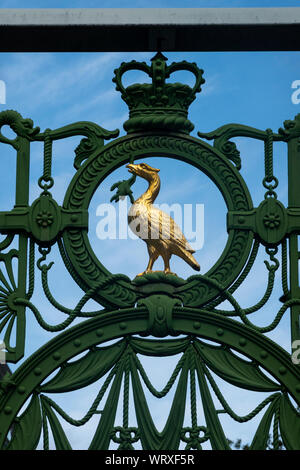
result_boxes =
[126,163,200,276]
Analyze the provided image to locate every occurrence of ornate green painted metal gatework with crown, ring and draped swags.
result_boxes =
[0,53,300,450]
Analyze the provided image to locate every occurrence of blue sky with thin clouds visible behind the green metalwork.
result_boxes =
[0,0,300,454]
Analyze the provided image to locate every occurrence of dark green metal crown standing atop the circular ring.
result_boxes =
[113,52,205,134]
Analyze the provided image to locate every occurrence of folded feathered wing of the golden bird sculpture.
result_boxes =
[149,206,195,253]
